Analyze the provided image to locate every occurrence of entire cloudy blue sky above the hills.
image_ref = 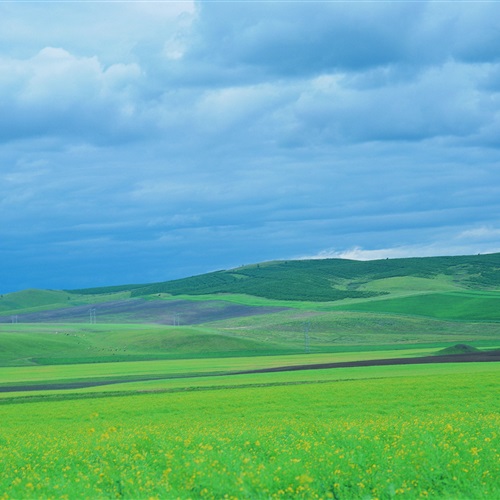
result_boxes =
[0,0,500,293]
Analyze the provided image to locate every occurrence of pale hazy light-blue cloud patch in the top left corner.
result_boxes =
[0,0,195,62]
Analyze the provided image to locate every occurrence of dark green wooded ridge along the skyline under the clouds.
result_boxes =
[67,253,500,302]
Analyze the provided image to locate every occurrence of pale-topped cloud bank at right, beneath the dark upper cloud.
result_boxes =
[284,63,499,146]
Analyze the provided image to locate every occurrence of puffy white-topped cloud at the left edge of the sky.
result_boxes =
[0,47,147,143]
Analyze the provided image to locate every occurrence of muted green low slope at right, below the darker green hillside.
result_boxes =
[210,308,500,351]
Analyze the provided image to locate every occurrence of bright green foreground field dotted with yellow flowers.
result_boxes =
[0,363,500,499]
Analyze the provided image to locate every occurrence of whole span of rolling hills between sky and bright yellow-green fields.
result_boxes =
[0,254,500,364]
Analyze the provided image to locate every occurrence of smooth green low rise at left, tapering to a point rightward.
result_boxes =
[0,323,294,366]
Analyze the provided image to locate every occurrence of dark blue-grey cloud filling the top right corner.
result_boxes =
[188,1,500,78]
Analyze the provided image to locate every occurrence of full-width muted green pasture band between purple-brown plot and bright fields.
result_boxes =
[0,318,500,366]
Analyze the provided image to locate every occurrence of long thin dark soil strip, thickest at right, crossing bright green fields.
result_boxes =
[0,351,500,393]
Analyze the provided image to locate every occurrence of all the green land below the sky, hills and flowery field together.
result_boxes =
[0,254,500,500]
